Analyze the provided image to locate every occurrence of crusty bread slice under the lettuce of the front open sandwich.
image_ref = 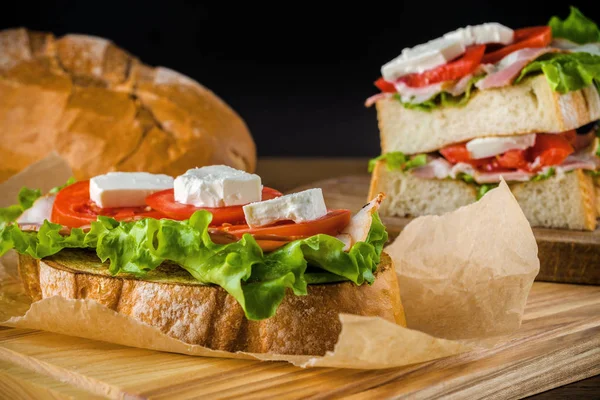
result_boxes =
[19,250,406,355]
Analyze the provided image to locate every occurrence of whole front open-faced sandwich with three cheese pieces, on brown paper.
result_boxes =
[0,165,405,355]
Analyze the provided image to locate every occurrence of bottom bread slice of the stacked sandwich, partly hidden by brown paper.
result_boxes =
[369,162,598,230]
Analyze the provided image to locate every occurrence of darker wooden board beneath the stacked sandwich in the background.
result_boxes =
[290,174,600,285]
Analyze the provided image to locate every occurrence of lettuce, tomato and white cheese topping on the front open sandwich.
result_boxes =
[0,166,388,320]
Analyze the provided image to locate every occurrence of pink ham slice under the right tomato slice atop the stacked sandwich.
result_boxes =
[475,47,559,90]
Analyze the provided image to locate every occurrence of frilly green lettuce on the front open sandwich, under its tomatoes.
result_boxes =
[0,211,387,320]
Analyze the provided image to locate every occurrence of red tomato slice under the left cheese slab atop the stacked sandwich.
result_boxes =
[398,44,485,87]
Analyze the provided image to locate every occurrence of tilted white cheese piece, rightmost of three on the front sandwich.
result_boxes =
[243,189,327,228]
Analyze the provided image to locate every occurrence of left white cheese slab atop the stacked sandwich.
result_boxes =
[381,38,465,82]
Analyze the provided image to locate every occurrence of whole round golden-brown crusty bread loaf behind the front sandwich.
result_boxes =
[0,29,256,181]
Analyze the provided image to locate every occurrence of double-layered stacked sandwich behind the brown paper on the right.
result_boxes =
[367,8,600,230]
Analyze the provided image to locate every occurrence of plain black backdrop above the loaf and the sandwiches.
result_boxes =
[0,0,600,156]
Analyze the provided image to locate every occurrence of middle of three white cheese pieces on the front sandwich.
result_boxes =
[175,165,262,208]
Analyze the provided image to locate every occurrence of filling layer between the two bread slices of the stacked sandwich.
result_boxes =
[369,121,600,197]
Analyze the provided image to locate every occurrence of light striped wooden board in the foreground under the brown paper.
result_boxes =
[0,282,600,399]
